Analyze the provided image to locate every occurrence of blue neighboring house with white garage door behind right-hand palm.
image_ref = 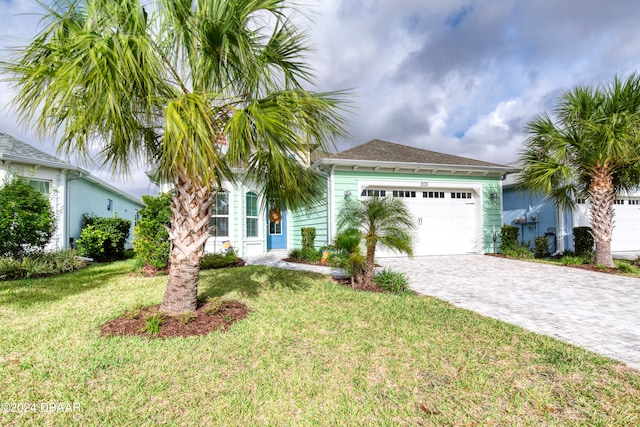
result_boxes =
[502,169,640,253]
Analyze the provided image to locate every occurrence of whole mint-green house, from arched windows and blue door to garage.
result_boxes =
[205,140,512,257]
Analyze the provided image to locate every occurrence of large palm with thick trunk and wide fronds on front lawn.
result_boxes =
[1,0,344,314]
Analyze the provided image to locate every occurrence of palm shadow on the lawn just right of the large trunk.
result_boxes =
[198,265,325,300]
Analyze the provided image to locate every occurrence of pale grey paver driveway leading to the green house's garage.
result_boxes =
[377,255,640,369]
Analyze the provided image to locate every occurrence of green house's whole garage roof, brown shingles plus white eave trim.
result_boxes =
[318,139,512,174]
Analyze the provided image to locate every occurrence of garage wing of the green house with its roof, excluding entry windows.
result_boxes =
[290,140,511,256]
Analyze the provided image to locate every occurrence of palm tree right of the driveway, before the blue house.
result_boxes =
[520,74,640,268]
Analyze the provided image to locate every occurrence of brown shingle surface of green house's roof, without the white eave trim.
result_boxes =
[327,139,504,167]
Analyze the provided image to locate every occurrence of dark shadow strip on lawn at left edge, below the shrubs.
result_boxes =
[0,264,126,308]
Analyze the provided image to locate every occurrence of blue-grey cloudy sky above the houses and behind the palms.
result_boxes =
[0,0,640,199]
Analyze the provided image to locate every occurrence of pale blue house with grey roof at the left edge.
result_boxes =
[0,132,144,250]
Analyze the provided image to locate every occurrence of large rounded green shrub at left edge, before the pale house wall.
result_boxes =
[0,176,55,259]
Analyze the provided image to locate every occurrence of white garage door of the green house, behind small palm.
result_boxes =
[372,188,477,256]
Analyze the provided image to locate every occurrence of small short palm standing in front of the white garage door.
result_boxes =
[337,197,415,288]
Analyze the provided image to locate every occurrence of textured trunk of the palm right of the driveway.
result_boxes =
[589,166,615,268]
